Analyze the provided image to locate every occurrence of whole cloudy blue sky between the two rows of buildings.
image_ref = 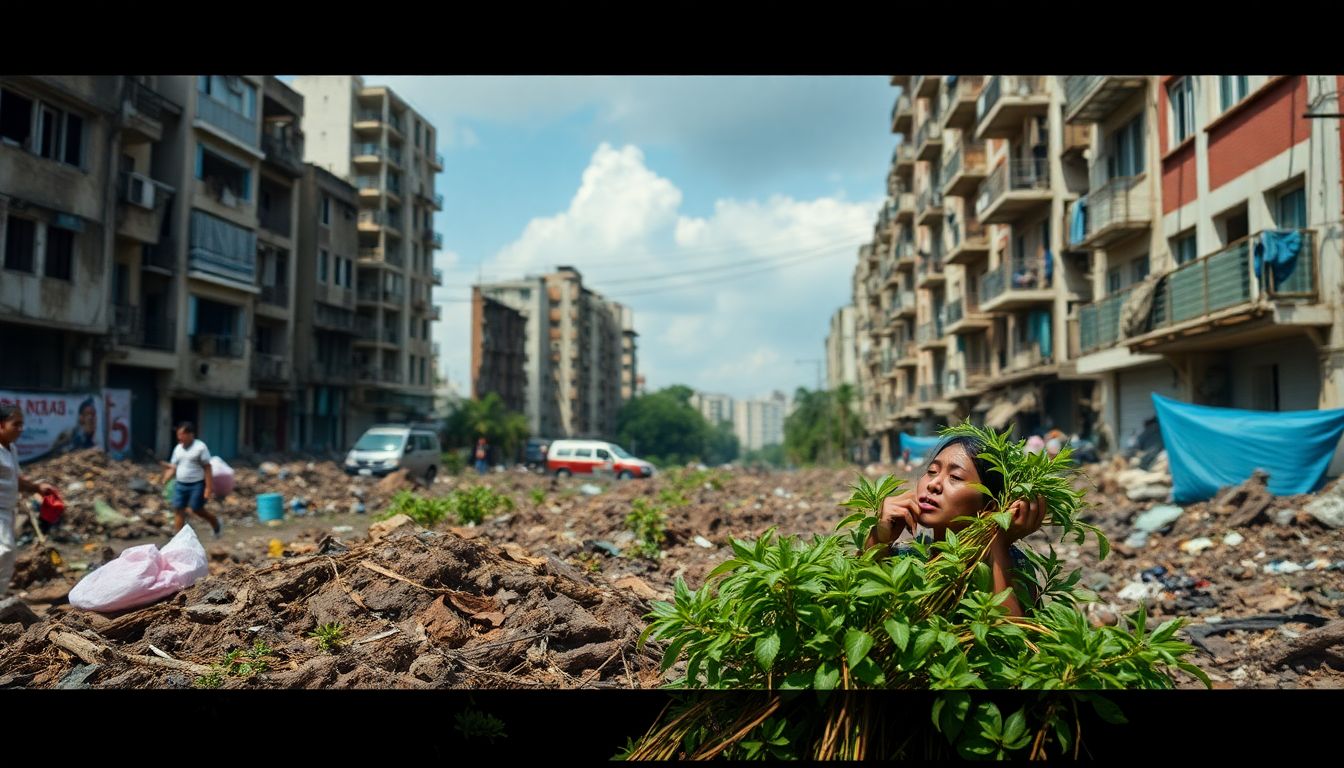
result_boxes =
[364,75,894,398]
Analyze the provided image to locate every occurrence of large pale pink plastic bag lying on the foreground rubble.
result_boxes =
[70,526,210,613]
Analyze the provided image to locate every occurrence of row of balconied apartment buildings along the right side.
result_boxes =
[855,75,1344,457]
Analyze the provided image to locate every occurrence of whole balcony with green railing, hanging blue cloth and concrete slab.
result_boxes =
[1125,230,1332,351]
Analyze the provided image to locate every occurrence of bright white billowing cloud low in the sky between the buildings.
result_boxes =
[441,144,880,397]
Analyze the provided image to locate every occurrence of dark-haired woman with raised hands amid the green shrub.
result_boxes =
[867,434,1047,616]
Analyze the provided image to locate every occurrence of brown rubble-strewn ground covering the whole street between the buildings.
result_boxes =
[0,453,1344,689]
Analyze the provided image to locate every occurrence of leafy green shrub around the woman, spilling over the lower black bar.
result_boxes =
[626,425,1208,759]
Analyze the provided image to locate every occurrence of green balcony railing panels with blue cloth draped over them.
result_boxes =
[1149,230,1317,330]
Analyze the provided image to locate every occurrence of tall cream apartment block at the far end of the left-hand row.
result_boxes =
[294,75,444,428]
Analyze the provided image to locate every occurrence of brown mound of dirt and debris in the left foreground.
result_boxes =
[0,518,660,689]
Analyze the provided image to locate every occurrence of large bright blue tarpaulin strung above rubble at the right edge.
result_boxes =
[1152,393,1344,503]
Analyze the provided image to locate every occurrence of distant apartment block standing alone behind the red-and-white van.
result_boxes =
[472,266,641,437]
